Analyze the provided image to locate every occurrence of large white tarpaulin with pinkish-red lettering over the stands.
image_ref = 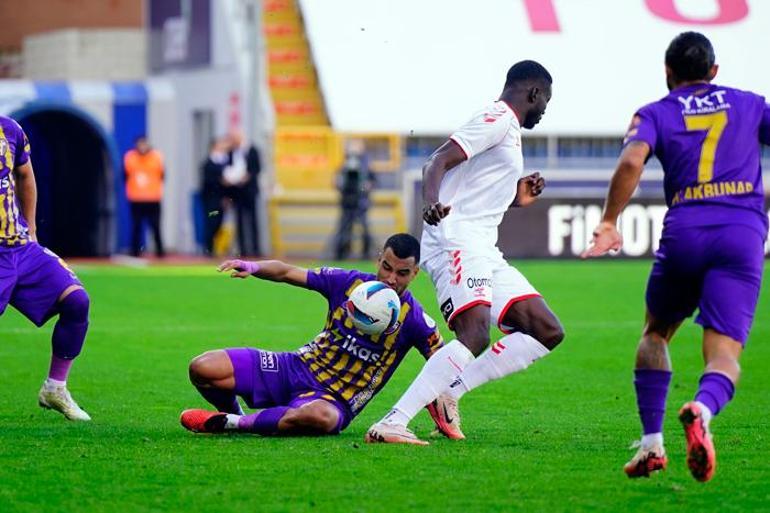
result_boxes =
[301,0,770,135]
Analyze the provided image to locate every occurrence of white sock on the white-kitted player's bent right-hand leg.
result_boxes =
[440,332,550,399]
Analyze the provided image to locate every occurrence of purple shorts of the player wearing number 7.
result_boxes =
[647,224,765,345]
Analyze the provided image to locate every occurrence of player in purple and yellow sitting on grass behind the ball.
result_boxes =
[181,234,456,435]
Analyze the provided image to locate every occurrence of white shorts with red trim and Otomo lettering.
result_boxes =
[422,249,540,333]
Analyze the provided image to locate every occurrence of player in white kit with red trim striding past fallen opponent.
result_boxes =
[366,61,564,444]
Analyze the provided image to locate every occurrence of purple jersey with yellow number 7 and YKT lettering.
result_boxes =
[624,83,770,236]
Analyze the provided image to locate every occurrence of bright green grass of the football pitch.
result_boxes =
[0,261,770,513]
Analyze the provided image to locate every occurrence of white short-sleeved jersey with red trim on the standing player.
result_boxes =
[421,101,524,261]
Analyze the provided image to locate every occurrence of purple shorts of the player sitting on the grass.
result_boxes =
[225,347,353,433]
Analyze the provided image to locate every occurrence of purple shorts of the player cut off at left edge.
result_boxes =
[0,242,81,326]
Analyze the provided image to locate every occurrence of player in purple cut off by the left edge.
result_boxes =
[0,116,91,420]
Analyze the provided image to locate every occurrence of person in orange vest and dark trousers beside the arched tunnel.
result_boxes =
[123,135,165,257]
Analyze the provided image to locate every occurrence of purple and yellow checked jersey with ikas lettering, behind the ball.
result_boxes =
[298,267,443,415]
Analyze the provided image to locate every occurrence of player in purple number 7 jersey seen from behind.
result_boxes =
[584,32,770,481]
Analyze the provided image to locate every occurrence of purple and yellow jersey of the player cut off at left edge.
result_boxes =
[0,116,29,248]
